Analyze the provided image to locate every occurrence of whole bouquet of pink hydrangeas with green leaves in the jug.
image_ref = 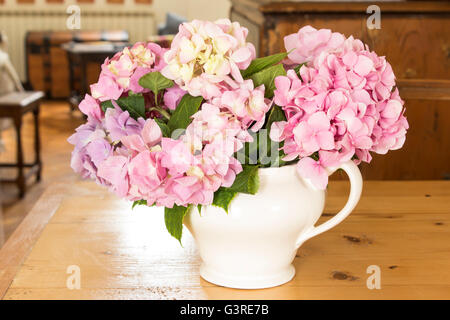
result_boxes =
[69,20,408,239]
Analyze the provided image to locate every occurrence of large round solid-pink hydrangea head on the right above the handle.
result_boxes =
[271,27,408,189]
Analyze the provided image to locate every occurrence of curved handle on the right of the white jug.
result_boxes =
[296,160,363,249]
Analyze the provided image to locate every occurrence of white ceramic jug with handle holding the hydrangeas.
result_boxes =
[184,161,362,289]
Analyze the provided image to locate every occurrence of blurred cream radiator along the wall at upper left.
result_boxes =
[0,8,155,81]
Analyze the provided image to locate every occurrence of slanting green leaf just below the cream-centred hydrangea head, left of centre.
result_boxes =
[167,94,203,133]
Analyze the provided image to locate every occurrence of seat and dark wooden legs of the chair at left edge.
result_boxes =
[0,91,44,198]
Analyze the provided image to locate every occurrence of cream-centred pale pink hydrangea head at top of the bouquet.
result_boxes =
[161,19,255,99]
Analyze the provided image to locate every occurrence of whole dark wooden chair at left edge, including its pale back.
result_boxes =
[0,31,44,198]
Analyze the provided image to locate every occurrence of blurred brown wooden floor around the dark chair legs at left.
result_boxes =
[0,101,83,247]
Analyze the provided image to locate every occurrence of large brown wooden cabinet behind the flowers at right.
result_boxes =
[231,0,450,179]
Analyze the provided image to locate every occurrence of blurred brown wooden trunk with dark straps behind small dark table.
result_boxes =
[25,30,129,98]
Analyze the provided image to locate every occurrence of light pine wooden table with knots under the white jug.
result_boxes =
[0,181,450,299]
